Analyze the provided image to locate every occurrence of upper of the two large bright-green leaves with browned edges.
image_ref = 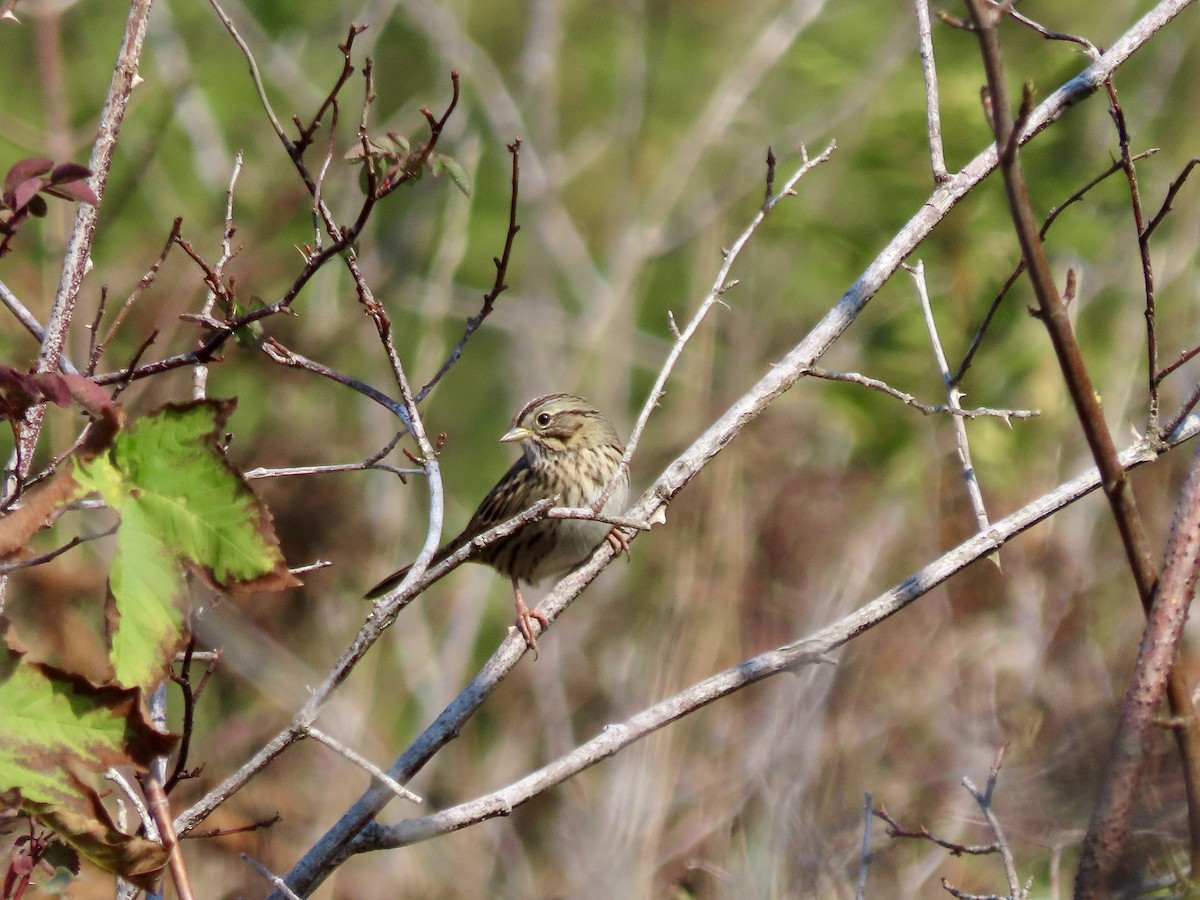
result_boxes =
[76,401,298,688]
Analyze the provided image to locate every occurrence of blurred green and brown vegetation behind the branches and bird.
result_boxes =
[0,0,1200,898]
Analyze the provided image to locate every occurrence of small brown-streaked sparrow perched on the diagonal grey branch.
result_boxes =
[366,394,629,653]
